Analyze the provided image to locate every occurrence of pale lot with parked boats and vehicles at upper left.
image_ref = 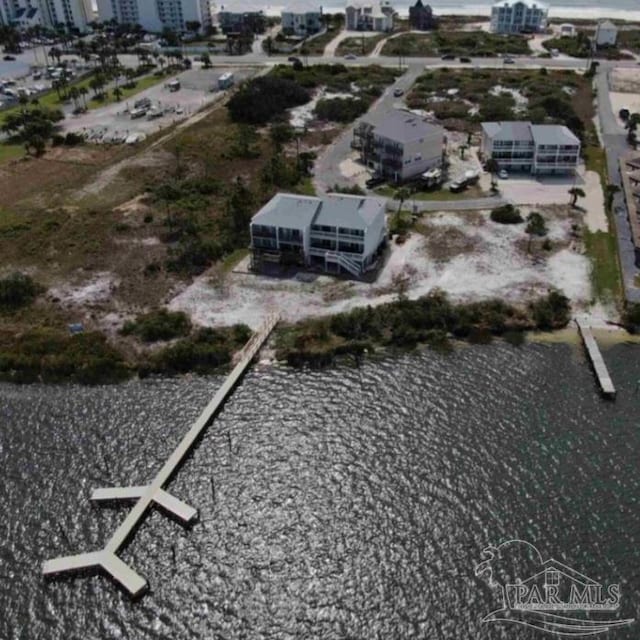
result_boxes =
[62,68,254,142]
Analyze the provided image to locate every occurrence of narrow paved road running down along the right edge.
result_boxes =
[596,69,640,302]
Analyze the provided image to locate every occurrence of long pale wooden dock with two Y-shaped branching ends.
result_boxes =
[42,314,279,597]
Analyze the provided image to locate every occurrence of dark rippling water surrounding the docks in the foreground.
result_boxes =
[0,345,640,640]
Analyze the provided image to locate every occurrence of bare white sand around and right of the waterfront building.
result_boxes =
[169,212,591,327]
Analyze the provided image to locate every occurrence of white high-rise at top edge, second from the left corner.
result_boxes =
[98,0,211,33]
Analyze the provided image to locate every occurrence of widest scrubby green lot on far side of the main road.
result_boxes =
[382,29,529,57]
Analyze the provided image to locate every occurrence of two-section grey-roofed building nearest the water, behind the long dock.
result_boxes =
[251,193,387,278]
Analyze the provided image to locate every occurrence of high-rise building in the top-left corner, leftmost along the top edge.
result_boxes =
[0,0,94,33]
